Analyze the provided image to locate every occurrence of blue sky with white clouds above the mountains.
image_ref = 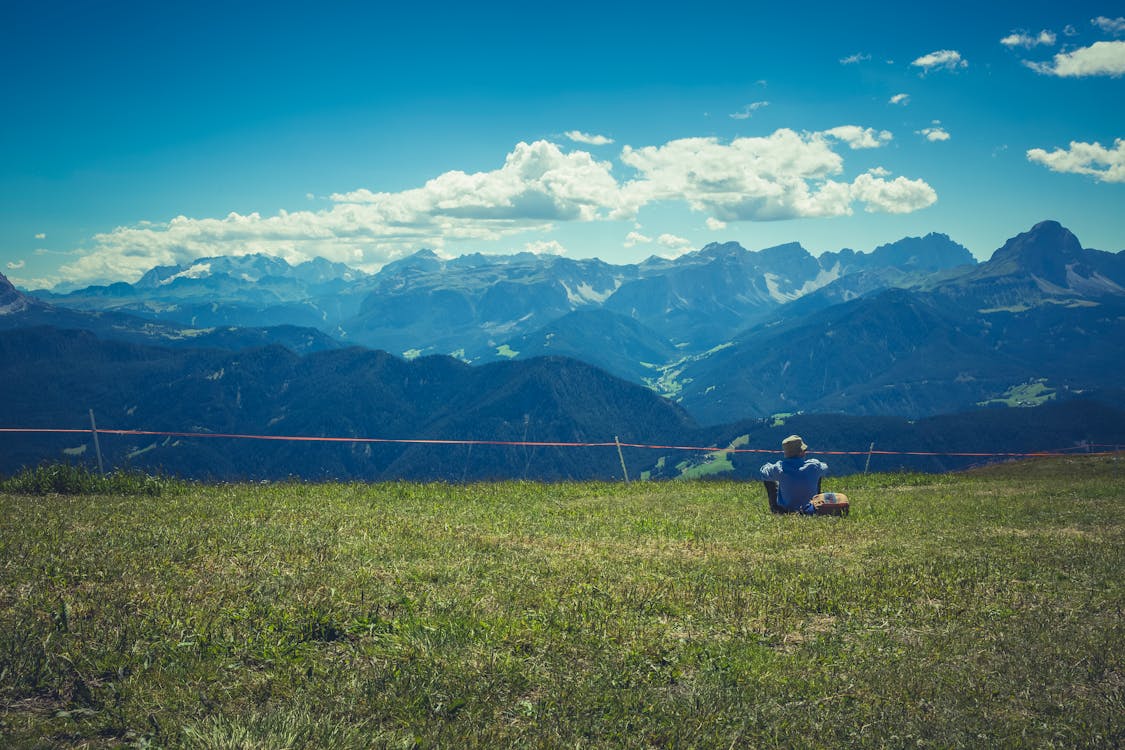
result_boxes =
[0,0,1125,289]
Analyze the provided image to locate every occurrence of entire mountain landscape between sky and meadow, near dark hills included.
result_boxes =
[0,222,1125,478]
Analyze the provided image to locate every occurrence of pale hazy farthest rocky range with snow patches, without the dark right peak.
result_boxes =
[34,234,973,362]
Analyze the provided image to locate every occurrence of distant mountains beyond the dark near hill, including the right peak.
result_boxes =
[21,222,1125,424]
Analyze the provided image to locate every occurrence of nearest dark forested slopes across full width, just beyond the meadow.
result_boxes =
[0,323,1125,480]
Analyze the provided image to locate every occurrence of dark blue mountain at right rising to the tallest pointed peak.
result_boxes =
[682,222,1125,421]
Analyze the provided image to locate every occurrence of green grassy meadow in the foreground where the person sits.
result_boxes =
[0,457,1125,748]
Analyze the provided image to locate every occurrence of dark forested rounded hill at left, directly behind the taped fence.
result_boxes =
[0,327,694,479]
